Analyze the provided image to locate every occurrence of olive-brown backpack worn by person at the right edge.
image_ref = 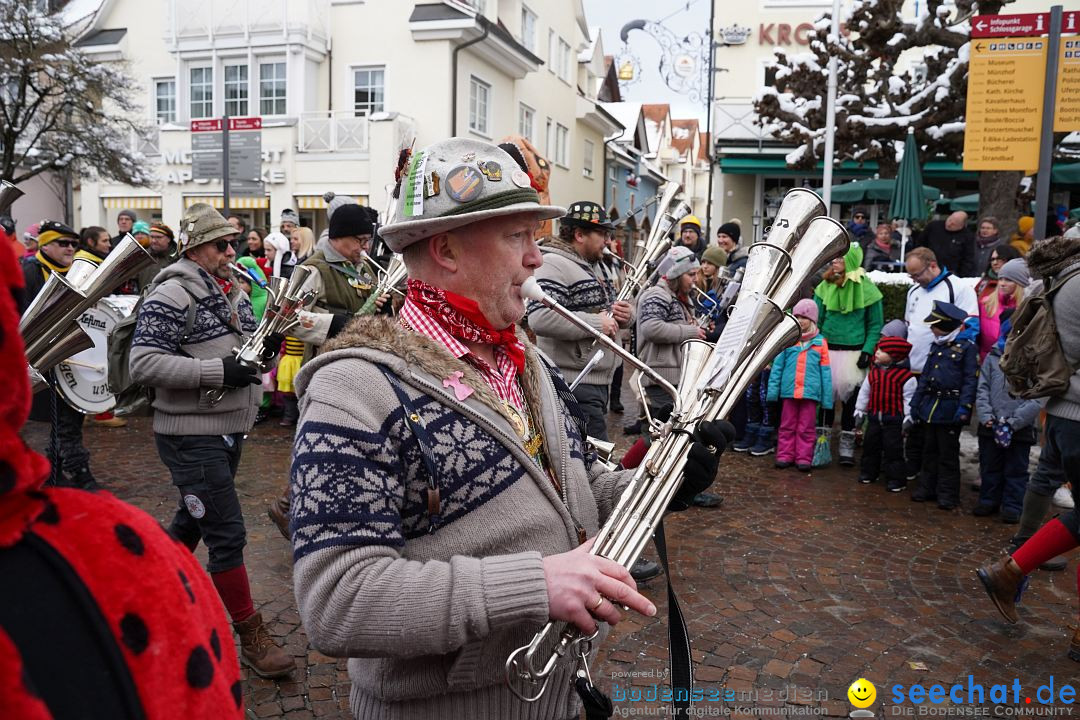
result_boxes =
[1000,269,1080,399]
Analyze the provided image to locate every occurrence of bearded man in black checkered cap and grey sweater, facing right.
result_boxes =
[528,201,634,440]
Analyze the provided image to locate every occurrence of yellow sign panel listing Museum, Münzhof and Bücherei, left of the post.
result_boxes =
[963,38,1048,172]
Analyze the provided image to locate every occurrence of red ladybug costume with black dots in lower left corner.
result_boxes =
[0,222,244,720]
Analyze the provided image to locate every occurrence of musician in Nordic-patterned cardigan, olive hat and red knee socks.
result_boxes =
[131,203,294,678]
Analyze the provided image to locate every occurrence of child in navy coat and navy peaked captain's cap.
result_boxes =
[912,300,978,511]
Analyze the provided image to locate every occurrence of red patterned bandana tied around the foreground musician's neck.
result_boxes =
[407,277,525,372]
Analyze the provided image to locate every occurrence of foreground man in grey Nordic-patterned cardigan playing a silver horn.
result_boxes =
[292,138,724,720]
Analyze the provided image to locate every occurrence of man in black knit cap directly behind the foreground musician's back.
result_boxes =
[267,203,387,539]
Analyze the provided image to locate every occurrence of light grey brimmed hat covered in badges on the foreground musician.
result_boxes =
[379,137,566,253]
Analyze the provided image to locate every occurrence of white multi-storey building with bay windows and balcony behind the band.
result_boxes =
[76,0,619,230]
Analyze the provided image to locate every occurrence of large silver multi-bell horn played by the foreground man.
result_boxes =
[505,185,841,703]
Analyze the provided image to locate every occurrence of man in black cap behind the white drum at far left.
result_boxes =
[18,220,98,490]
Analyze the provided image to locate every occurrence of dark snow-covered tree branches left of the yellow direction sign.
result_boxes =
[754,0,1012,173]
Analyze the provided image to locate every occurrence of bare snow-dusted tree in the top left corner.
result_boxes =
[0,0,153,186]
